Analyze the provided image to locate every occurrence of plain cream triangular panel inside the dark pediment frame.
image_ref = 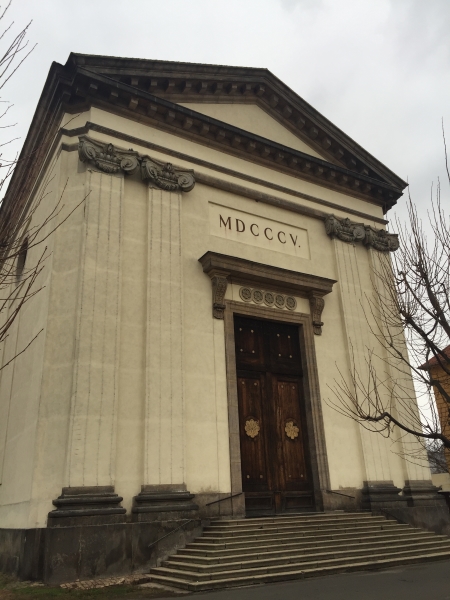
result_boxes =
[179,102,330,164]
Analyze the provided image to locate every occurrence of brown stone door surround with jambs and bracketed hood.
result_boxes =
[198,251,336,516]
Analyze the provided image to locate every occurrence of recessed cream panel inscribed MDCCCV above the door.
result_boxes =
[209,202,310,259]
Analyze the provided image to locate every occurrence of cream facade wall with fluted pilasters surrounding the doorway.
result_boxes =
[0,109,429,527]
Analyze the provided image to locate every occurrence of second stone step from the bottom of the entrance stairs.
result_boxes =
[162,540,450,573]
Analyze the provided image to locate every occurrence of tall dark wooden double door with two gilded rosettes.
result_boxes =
[234,316,314,516]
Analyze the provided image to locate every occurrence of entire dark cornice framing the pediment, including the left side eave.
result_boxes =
[1,54,406,220]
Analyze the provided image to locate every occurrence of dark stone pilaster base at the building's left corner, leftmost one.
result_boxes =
[47,486,126,527]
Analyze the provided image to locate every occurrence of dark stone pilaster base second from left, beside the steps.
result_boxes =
[132,484,198,521]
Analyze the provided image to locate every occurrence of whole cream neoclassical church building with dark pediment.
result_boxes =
[0,54,448,581]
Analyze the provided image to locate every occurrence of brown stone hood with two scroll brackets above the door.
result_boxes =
[198,252,336,335]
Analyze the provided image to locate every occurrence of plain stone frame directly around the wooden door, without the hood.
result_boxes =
[224,300,330,515]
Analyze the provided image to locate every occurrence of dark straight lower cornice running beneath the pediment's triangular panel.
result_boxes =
[66,68,400,211]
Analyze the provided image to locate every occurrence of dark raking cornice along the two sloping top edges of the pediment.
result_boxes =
[70,54,406,188]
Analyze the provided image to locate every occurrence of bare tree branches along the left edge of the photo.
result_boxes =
[0,0,85,370]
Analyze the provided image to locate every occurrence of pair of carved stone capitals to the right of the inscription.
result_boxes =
[325,215,399,252]
